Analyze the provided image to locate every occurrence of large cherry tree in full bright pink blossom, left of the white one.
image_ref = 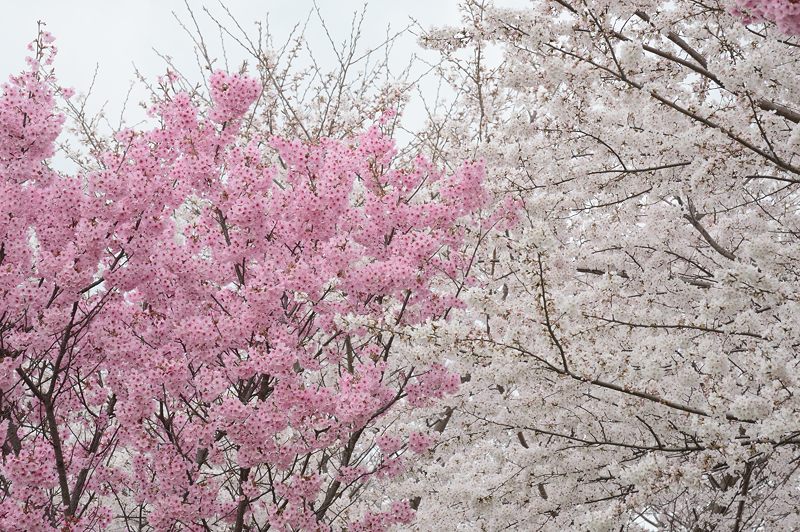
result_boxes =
[0,27,494,531]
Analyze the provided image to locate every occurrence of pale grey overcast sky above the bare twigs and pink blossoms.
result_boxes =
[0,0,525,136]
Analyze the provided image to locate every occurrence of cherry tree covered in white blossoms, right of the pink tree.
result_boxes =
[397,0,800,531]
